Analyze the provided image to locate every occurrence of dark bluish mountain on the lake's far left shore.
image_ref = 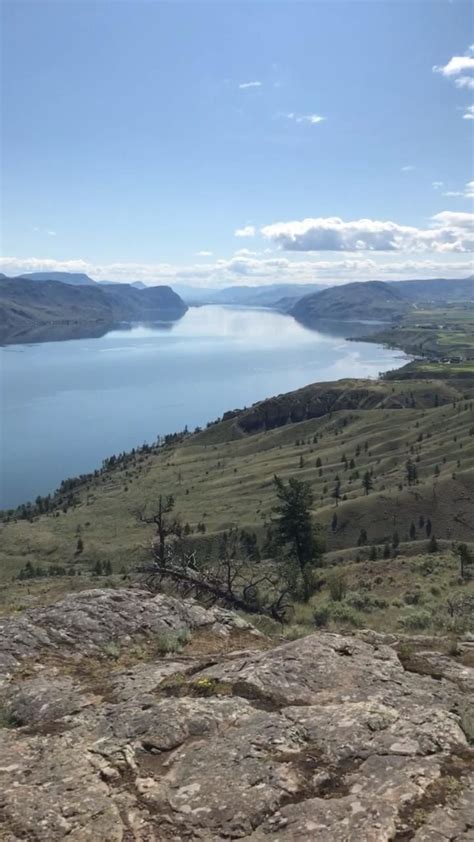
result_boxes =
[0,277,188,343]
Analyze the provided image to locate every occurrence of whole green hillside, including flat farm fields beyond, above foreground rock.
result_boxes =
[0,302,474,634]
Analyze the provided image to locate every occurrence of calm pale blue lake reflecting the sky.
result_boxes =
[0,306,405,508]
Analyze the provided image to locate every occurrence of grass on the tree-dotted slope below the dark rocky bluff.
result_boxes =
[0,383,474,583]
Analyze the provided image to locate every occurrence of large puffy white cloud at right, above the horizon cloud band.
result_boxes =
[261,211,474,253]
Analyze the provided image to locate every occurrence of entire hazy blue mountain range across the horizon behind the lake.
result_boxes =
[0,272,474,342]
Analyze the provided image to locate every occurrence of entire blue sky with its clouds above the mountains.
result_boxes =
[0,0,474,287]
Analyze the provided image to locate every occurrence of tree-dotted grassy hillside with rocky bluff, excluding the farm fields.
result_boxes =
[0,372,474,626]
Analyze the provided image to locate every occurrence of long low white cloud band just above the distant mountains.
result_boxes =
[0,254,472,288]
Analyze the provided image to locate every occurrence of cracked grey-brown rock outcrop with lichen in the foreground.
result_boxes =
[0,590,474,842]
